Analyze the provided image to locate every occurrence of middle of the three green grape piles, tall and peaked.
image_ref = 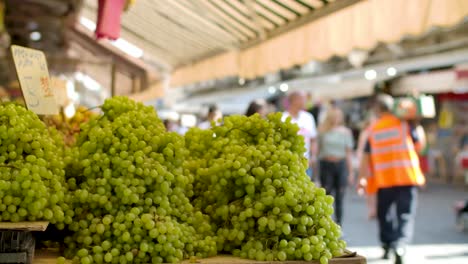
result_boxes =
[61,97,217,264]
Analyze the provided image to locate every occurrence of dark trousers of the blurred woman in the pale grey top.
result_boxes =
[320,160,347,225]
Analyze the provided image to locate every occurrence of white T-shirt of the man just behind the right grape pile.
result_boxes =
[281,111,317,159]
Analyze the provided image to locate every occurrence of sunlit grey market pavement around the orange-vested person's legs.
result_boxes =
[343,185,468,264]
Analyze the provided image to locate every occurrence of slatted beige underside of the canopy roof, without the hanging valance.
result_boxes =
[82,0,352,68]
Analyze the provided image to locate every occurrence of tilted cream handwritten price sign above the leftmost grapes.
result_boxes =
[11,45,58,115]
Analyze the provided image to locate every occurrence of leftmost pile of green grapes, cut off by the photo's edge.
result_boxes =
[0,103,73,226]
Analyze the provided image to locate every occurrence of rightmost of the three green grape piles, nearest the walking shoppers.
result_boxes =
[184,113,346,264]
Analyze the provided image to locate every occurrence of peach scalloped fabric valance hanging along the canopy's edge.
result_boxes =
[173,0,468,86]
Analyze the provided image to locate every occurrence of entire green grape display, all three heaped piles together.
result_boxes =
[0,97,346,264]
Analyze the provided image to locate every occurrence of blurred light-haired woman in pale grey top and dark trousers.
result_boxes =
[318,107,354,225]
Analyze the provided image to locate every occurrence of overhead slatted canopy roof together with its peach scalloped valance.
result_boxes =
[82,0,468,98]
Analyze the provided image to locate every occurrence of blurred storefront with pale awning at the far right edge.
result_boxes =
[392,65,468,185]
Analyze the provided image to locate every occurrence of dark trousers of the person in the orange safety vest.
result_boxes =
[377,186,417,247]
